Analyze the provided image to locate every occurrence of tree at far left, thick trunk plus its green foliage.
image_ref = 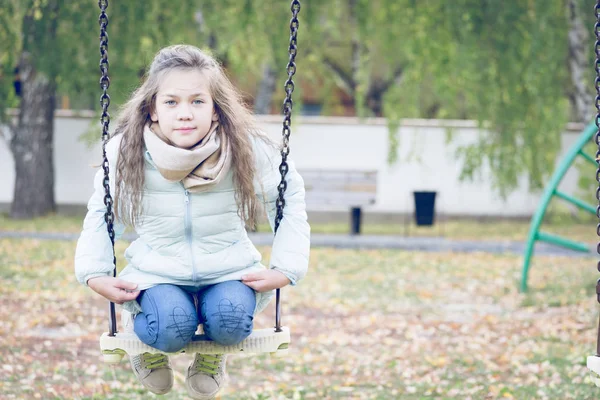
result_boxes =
[0,0,199,218]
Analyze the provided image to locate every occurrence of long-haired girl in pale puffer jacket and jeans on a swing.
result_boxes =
[75,45,310,399]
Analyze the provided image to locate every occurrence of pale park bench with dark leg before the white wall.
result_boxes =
[298,169,377,235]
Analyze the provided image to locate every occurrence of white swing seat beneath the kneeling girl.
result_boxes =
[100,326,290,364]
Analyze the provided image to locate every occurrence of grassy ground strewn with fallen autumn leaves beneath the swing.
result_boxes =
[0,239,600,400]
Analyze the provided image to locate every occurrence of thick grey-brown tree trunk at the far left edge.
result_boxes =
[4,0,59,218]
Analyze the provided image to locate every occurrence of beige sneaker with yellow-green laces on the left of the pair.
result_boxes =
[130,353,173,394]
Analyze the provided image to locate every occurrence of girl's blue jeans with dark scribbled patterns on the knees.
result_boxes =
[134,281,256,353]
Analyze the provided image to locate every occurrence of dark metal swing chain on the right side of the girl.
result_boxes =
[275,0,300,332]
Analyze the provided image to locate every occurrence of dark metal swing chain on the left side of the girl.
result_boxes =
[98,0,117,336]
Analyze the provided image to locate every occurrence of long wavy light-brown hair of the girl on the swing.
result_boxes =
[113,45,268,226]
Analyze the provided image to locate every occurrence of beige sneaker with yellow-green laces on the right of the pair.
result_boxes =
[185,353,227,400]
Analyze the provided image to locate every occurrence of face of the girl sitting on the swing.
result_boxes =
[150,69,218,149]
